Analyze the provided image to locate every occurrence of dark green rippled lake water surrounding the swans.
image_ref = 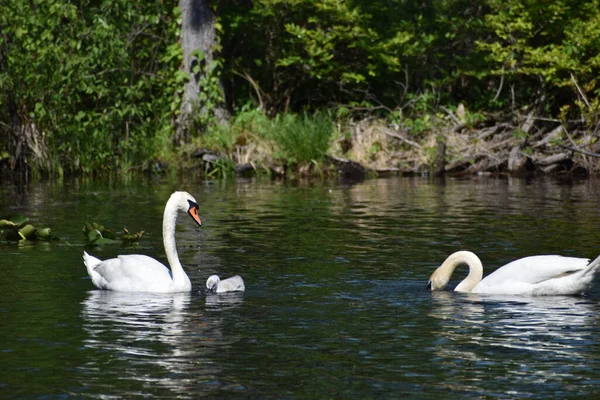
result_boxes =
[0,177,600,399]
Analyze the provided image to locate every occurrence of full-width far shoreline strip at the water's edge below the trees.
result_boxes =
[0,115,600,182]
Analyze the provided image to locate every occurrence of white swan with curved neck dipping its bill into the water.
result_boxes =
[427,251,600,296]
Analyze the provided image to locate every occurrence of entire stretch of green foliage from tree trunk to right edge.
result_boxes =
[217,0,600,124]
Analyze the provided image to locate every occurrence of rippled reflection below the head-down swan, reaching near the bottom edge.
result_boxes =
[429,292,600,397]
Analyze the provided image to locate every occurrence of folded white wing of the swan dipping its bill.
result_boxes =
[473,256,590,292]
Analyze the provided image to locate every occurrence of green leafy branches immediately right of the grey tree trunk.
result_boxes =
[217,0,411,115]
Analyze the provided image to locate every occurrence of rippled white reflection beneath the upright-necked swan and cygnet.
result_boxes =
[81,290,243,395]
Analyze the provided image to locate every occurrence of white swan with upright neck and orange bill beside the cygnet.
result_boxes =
[83,192,202,293]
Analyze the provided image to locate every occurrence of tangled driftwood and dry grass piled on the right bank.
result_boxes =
[332,112,600,175]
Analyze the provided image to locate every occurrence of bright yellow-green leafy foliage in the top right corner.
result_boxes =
[478,0,600,115]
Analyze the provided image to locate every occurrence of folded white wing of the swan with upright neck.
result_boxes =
[94,254,173,292]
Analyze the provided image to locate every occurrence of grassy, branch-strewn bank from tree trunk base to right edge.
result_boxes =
[175,105,600,181]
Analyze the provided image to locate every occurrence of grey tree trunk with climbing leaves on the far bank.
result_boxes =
[174,0,229,144]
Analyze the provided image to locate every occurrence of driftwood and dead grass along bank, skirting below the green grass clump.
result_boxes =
[190,112,600,180]
